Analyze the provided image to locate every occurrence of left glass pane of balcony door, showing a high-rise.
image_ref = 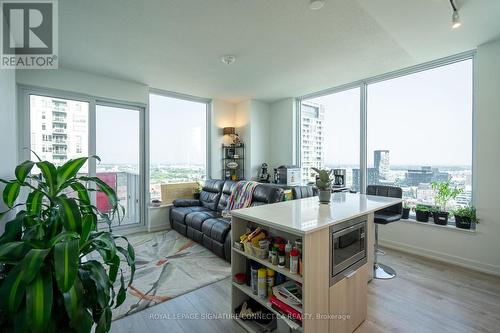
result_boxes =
[30,95,89,165]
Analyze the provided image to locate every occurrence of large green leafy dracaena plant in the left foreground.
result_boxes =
[0,156,135,332]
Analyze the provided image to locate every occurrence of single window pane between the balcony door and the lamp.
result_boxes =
[149,94,208,199]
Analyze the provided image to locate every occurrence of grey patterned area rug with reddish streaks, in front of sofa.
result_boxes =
[113,230,231,320]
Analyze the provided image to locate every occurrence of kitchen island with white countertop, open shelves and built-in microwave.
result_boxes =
[231,193,401,333]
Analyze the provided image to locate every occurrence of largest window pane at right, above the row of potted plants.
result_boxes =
[367,59,472,209]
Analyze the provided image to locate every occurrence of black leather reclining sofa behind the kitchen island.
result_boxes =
[170,179,283,261]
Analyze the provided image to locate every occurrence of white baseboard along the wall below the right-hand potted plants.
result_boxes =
[379,239,500,276]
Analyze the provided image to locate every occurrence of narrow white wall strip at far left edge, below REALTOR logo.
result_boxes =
[0,69,17,234]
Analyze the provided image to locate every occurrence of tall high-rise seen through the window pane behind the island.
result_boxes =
[300,102,325,182]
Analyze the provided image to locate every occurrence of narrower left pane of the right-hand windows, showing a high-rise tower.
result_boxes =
[300,88,360,190]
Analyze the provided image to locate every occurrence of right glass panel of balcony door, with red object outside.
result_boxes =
[95,105,140,225]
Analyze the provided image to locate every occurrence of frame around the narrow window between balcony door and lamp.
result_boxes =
[146,88,212,200]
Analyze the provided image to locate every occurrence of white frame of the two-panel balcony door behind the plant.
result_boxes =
[17,84,149,232]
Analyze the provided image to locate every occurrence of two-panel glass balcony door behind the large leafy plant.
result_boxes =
[27,90,144,226]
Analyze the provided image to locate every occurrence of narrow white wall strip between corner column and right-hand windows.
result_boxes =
[269,98,296,170]
